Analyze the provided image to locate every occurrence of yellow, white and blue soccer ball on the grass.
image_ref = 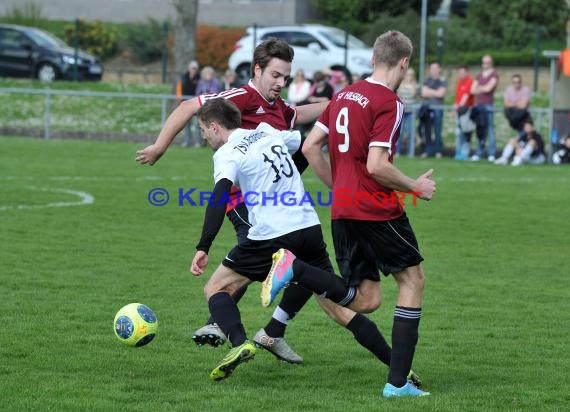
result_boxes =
[113,303,158,346]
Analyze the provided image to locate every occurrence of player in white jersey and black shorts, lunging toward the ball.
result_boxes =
[190,99,415,380]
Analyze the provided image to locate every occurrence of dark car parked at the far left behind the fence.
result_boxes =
[0,24,103,82]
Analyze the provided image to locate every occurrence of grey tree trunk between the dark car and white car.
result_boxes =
[172,0,198,74]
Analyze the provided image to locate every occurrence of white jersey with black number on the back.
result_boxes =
[214,123,320,240]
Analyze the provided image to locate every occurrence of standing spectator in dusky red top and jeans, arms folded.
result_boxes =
[471,54,499,162]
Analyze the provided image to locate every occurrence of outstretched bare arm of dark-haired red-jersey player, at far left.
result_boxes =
[135,97,200,166]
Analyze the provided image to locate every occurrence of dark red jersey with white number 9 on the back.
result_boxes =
[316,77,404,220]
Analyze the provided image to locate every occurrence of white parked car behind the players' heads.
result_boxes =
[228,24,372,83]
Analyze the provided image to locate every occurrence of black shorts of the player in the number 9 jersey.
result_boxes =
[332,213,424,286]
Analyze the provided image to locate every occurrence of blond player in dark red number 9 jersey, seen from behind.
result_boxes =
[262,31,436,397]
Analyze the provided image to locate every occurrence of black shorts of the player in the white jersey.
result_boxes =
[222,225,332,282]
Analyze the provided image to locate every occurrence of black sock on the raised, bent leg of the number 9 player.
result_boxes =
[293,259,356,306]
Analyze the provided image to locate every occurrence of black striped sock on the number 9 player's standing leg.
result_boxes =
[388,306,422,388]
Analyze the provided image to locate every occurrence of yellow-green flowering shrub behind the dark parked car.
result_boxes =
[65,19,119,59]
